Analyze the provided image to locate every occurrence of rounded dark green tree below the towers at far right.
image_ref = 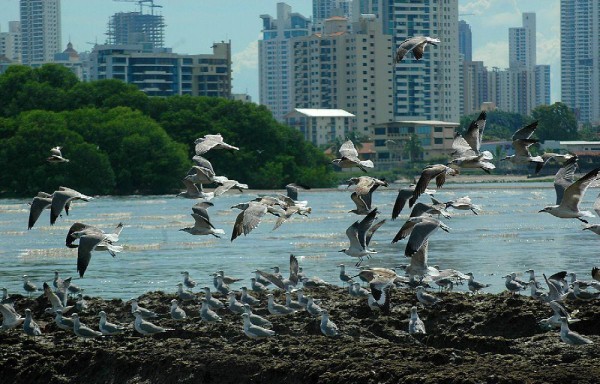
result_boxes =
[531,102,578,141]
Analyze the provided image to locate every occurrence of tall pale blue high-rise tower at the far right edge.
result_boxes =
[560,0,600,124]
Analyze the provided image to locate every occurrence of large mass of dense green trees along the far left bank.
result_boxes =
[0,65,334,196]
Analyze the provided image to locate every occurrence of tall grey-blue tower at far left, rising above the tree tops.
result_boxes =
[19,0,63,65]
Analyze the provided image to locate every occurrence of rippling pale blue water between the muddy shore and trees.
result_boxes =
[0,182,600,299]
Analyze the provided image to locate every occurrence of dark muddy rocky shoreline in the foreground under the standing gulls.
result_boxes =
[0,287,600,383]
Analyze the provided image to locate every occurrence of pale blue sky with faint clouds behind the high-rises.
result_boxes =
[0,0,560,102]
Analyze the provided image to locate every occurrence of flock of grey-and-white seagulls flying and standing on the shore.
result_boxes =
[8,36,600,345]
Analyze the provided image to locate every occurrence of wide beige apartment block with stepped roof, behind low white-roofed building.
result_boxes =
[293,15,393,135]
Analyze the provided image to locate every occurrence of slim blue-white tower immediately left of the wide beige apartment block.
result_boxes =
[258,3,310,122]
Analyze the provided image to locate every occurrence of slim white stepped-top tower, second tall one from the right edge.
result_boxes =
[508,12,536,70]
